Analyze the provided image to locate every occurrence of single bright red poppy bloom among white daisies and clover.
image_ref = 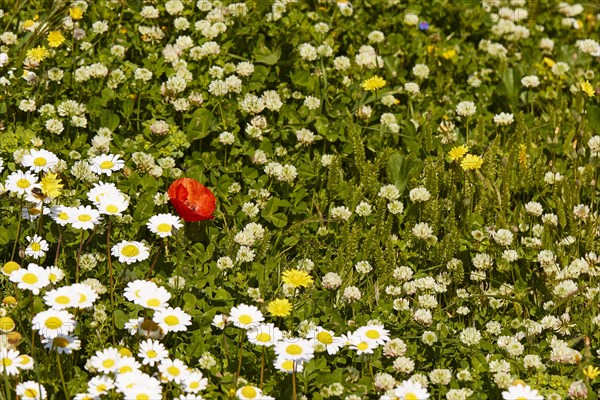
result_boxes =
[167,178,217,222]
